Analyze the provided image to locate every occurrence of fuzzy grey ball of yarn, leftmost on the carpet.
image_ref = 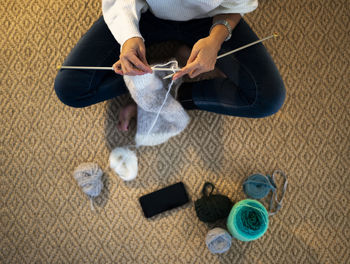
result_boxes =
[74,163,103,197]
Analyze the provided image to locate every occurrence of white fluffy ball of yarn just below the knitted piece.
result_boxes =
[109,148,137,181]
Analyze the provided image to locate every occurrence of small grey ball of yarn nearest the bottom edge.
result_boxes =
[205,227,232,254]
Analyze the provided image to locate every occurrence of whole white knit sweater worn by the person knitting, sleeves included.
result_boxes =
[102,0,258,46]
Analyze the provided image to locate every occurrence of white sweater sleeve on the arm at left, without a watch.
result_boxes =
[102,0,148,49]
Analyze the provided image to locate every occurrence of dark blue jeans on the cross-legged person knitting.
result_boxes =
[54,11,286,118]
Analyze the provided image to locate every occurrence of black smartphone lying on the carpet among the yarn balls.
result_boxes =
[139,182,189,218]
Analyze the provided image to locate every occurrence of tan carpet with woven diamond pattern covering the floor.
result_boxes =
[0,0,350,263]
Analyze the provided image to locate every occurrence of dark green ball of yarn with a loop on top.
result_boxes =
[194,182,233,223]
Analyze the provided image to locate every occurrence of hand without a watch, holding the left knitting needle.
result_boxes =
[113,37,152,76]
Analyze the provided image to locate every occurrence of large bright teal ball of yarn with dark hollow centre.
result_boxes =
[227,199,269,241]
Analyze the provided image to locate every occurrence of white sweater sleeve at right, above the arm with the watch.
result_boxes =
[208,0,258,17]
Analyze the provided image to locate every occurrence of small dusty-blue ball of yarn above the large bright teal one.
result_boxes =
[243,174,275,199]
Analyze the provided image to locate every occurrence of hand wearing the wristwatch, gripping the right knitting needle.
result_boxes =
[173,37,220,80]
